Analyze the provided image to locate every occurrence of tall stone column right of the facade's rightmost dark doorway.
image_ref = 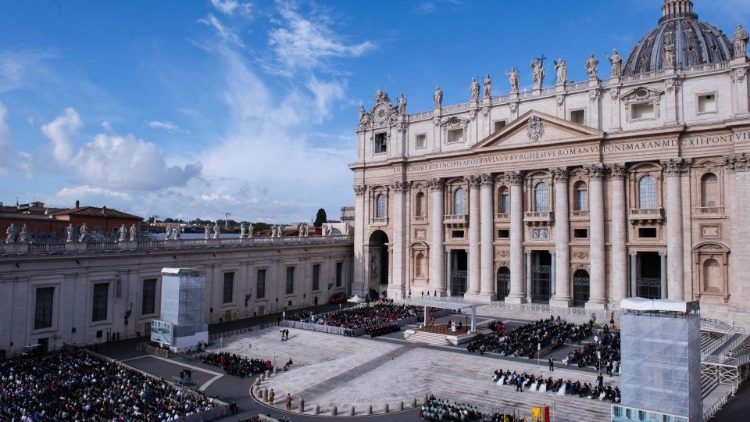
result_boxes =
[662,159,685,300]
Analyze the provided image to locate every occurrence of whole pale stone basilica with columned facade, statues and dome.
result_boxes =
[350,0,750,324]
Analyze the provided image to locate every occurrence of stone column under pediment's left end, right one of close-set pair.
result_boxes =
[479,174,496,302]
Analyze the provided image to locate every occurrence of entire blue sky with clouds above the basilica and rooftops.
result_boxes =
[0,0,750,223]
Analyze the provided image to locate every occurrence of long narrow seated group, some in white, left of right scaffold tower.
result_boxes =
[492,369,620,403]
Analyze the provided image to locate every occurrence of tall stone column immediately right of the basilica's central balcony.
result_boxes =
[550,167,570,307]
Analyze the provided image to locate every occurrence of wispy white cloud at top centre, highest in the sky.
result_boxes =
[269,4,375,73]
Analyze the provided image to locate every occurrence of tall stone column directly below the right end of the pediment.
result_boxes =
[586,165,607,311]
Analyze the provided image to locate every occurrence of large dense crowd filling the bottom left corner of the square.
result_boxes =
[0,350,217,422]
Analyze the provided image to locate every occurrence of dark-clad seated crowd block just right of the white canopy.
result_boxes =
[467,316,594,359]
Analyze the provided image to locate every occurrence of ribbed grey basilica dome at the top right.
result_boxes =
[623,0,732,76]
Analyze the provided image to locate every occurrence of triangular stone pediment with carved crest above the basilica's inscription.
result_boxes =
[474,110,604,149]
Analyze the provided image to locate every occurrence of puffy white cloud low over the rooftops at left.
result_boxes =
[73,134,201,191]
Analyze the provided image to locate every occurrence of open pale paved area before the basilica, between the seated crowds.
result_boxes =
[211,328,618,420]
